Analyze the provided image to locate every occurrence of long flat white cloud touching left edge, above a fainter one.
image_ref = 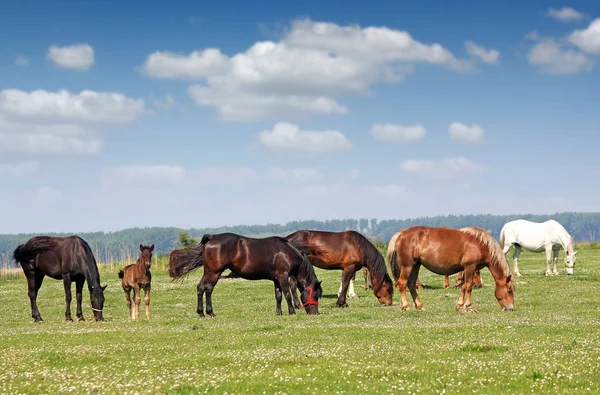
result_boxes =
[0,89,144,124]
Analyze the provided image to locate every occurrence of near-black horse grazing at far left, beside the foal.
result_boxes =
[13,236,106,322]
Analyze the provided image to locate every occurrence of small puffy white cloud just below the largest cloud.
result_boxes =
[258,122,352,153]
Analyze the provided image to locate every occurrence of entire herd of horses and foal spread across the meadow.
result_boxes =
[13,220,577,322]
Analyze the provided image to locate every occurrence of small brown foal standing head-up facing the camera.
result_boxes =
[119,244,154,320]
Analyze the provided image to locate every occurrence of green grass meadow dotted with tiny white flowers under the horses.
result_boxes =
[0,247,600,394]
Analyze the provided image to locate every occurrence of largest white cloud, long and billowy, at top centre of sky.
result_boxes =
[139,20,472,120]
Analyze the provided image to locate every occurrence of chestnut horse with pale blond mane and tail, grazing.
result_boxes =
[391,226,514,311]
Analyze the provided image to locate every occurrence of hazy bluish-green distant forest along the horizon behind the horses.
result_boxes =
[0,213,600,267]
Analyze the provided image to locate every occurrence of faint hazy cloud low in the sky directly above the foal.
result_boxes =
[101,165,186,190]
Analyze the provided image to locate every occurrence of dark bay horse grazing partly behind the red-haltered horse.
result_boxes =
[285,230,394,307]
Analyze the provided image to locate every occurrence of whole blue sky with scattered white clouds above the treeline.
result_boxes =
[0,0,600,233]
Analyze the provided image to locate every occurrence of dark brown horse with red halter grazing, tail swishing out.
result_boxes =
[169,233,322,317]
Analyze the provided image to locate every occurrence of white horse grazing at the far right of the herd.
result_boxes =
[500,219,577,276]
